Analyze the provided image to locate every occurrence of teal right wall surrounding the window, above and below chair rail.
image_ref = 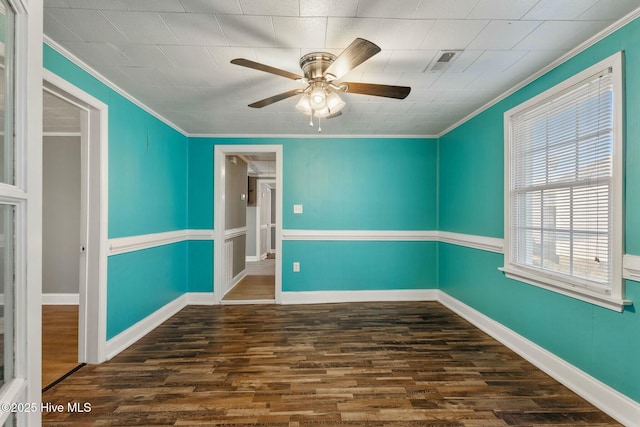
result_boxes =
[438,15,640,401]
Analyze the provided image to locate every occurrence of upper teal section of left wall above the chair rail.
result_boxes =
[44,45,188,238]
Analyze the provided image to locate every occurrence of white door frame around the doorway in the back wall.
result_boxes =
[213,144,282,304]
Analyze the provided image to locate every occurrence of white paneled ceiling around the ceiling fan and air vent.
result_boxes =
[44,0,640,135]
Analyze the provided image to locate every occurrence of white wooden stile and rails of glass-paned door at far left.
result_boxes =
[7,0,43,426]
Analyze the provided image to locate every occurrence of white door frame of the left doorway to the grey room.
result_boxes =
[43,70,109,363]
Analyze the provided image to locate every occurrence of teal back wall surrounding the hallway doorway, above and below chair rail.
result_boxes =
[189,138,437,292]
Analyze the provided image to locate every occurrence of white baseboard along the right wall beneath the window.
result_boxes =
[438,291,640,426]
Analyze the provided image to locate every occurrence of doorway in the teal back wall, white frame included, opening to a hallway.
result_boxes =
[213,145,282,304]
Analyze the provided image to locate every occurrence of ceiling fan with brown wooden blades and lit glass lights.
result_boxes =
[231,38,411,125]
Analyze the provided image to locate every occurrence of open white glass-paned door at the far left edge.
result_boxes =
[0,0,42,426]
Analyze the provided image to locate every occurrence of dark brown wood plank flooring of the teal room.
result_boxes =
[43,302,618,427]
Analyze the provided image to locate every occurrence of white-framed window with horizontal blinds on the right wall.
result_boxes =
[503,54,626,310]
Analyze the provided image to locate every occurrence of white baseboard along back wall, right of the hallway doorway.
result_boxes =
[282,289,439,304]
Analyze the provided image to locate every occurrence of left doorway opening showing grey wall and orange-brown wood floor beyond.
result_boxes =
[42,90,82,390]
